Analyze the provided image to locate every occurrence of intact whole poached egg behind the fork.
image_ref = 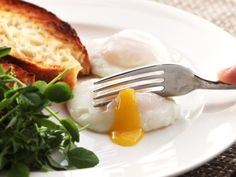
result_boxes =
[86,30,171,77]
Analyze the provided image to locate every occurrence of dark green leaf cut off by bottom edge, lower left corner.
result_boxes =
[7,163,29,177]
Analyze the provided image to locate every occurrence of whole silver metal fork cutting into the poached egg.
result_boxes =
[93,64,236,107]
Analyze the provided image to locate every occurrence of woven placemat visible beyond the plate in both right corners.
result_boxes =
[156,0,236,177]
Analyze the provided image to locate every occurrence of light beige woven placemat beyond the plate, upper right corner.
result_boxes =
[159,0,236,36]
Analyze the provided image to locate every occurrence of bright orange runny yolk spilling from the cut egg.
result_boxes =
[110,89,144,146]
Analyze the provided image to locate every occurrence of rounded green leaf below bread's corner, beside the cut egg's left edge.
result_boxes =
[44,82,73,103]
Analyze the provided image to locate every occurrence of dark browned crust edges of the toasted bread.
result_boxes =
[0,0,91,87]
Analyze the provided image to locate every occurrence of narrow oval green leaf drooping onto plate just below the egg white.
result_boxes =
[60,118,79,142]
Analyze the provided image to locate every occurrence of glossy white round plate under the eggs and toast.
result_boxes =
[17,0,236,177]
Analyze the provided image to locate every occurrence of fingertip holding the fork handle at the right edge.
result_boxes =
[218,66,236,84]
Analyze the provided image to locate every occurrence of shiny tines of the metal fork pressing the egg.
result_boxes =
[93,65,164,107]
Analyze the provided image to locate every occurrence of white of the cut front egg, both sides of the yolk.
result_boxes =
[67,79,181,132]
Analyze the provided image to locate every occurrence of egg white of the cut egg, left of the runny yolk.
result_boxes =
[67,79,114,132]
